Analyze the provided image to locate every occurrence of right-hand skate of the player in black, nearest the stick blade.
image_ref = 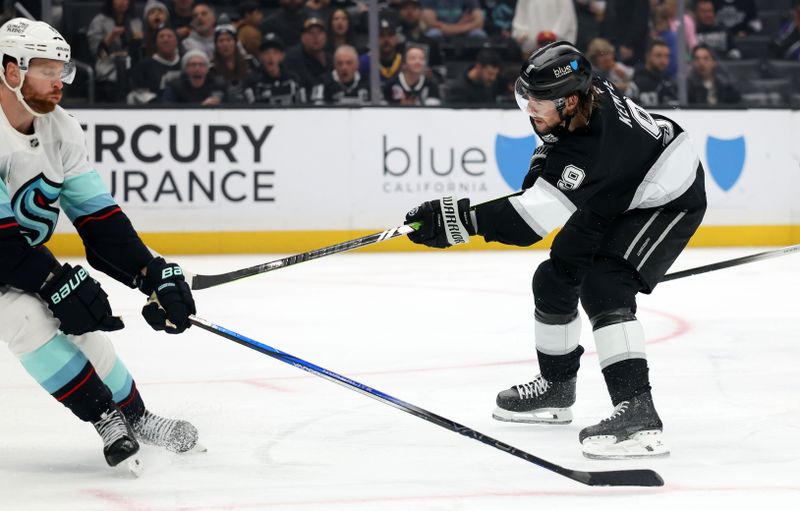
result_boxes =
[578,392,669,459]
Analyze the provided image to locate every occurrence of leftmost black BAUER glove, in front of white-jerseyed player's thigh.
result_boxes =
[39,264,125,335]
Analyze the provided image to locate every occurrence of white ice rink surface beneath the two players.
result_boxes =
[0,248,800,511]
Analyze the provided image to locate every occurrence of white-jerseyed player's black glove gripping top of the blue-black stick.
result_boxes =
[137,257,197,334]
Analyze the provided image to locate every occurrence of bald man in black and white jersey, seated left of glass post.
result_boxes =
[311,44,369,105]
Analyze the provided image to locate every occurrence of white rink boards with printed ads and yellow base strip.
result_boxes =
[50,108,800,255]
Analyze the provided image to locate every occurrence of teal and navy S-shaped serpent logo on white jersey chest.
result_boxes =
[11,174,61,247]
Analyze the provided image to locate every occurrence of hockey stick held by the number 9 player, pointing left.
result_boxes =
[184,191,523,291]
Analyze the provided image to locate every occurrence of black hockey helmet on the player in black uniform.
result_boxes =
[517,41,592,100]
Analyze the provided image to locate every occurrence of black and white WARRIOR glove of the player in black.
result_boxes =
[405,197,476,248]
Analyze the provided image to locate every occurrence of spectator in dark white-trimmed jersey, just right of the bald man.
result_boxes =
[383,45,441,106]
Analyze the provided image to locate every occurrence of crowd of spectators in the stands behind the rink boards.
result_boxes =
[6,0,800,107]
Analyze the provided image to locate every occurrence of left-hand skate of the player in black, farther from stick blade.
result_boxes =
[492,375,576,424]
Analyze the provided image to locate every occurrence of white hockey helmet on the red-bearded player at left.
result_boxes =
[0,18,75,116]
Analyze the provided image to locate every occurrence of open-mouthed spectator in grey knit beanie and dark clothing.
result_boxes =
[161,49,225,106]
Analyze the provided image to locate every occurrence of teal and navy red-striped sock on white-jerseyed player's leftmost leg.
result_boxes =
[20,333,114,422]
